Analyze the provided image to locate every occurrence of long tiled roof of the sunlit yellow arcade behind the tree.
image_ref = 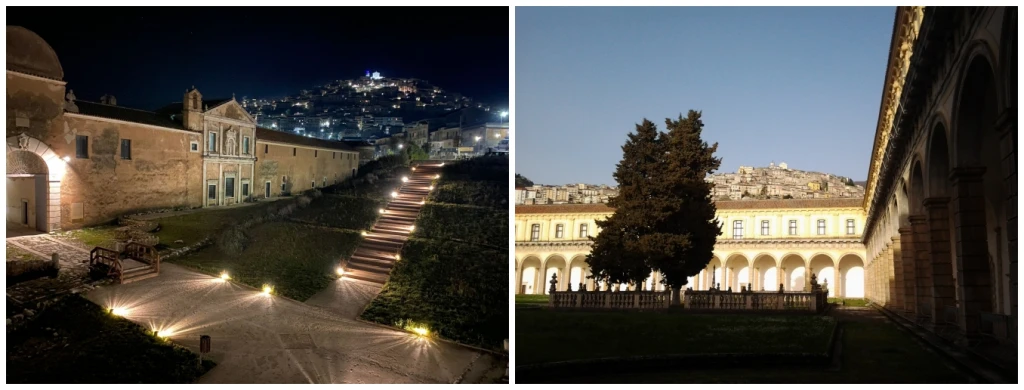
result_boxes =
[515,198,863,214]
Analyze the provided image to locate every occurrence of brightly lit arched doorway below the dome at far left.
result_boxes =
[6,134,65,232]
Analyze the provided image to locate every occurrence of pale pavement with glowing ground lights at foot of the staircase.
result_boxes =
[85,264,504,383]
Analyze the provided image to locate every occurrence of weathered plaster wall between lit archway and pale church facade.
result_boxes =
[61,115,203,228]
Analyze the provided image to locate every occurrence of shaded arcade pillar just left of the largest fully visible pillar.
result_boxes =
[925,198,956,323]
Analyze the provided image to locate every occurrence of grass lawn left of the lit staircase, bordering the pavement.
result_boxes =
[171,222,361,301]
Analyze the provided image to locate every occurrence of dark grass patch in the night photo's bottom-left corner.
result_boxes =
[7,296,214,384]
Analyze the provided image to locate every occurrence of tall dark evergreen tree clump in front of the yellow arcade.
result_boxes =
[587,111,721,303]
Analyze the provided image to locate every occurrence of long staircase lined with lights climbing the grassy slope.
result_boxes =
[342,163,441,285]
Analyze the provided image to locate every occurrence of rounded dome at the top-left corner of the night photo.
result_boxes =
[7,26,63,80]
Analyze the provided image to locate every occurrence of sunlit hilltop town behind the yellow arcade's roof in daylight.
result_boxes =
[515,163,864,205]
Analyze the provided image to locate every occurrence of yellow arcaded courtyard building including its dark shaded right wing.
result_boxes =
[514,7,1018,344]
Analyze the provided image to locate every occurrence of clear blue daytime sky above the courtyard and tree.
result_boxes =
[514,7,895,185]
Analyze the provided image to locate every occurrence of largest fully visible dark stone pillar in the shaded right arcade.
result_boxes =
[949,167,992,338]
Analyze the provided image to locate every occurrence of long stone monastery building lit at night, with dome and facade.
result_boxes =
[7,26,359,231]
